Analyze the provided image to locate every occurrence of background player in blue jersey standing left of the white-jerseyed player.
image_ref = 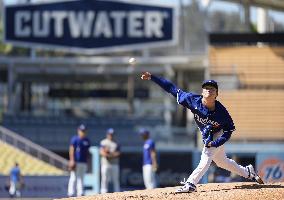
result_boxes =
[68,124,90,196]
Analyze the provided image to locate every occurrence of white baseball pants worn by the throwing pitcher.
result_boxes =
[187,145,249,185]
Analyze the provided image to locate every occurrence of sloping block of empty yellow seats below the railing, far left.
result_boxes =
[0,140,65,175]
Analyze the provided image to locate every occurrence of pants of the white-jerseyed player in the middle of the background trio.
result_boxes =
[101,165,120,194]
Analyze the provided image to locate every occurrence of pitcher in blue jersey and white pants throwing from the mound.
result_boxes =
[141,72,263,193]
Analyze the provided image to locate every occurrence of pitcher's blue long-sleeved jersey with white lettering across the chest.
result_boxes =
[151,75,235,147]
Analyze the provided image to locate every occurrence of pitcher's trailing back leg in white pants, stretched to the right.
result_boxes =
[213,145,249,178]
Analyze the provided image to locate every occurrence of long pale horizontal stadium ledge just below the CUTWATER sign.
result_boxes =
[0,55,205,82]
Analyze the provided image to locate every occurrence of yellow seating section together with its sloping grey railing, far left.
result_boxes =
[0,127,68,175]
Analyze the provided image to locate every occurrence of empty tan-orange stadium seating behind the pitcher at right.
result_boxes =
[209,46,284,141]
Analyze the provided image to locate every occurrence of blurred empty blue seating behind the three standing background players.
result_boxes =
[3,115,164,151]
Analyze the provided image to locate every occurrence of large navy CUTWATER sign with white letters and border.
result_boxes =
[4,0,178,53]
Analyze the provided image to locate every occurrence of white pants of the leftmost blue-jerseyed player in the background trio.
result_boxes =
[68,163,87,197]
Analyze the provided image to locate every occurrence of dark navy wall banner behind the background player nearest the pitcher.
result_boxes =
[120,152,192,190]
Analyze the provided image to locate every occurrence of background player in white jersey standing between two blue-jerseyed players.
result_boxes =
[100,128,120,193]
